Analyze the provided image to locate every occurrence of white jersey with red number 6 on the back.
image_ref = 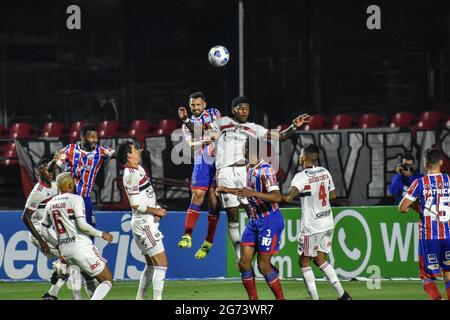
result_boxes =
[42,193,92,245]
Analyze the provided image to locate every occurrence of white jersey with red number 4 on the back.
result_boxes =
[291,167,334,235]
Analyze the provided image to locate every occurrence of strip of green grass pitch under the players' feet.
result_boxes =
[0,279,436,300]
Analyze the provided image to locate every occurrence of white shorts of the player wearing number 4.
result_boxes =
[297,229,334,257]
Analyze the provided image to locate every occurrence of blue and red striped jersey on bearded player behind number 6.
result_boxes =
[60,143,113,197]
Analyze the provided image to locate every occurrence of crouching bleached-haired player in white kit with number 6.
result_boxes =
[41,172,113,300]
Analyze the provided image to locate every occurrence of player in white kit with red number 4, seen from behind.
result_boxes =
[282,144,351,300]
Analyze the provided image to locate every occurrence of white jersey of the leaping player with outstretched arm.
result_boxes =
[213,117,268,169]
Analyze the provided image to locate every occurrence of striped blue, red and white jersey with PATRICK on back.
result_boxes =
[405,173,450,240]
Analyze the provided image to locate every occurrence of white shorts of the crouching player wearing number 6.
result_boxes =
[59,242,108,277]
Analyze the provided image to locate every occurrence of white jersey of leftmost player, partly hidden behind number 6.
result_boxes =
[25,181,59,224]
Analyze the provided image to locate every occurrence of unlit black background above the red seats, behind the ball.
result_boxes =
[0,0,450,128]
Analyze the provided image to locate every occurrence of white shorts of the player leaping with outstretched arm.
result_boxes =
[216,166,248,208]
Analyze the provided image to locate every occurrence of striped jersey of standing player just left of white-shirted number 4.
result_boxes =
[247,160,280,220]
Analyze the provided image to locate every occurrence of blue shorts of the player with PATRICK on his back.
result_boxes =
[419,239,450,278]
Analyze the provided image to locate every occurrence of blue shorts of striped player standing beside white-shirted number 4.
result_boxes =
[241,210,284,254]
